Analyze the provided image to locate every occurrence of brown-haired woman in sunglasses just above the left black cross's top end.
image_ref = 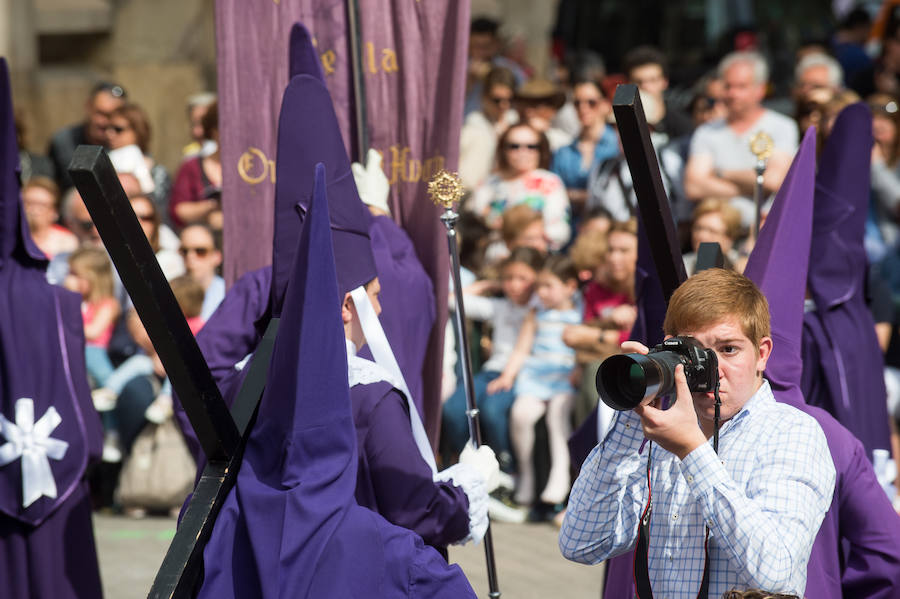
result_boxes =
[106,103,172,219]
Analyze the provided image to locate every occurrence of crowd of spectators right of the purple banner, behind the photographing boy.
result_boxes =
[442,10,900,519]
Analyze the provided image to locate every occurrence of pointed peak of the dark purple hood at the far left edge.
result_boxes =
[0,58,49,268]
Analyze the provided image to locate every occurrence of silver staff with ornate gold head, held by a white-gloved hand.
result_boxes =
[428,171,500,599]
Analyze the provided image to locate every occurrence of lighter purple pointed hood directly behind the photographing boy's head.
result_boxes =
[744,127,816,405]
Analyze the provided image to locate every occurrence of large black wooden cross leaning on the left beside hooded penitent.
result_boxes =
[69,146,278,599]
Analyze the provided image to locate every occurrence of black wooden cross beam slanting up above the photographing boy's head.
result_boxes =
[613,84,687,304]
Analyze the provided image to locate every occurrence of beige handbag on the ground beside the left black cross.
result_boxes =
[119,416,197,510]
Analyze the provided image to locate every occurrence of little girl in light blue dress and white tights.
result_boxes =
[498,255,581,505]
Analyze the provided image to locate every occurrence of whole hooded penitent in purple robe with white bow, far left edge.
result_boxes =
[0,59,103,599]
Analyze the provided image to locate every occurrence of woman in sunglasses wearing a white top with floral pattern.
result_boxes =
[468,123,572,257]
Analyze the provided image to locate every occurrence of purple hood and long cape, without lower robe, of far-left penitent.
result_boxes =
[0,59,102,526]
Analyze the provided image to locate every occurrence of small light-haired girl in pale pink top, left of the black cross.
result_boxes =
[64,247,121,387]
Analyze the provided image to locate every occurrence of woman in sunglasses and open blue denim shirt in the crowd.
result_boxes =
[550,79,619,219]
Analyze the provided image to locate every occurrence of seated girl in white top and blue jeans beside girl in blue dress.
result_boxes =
[442,247,542,472]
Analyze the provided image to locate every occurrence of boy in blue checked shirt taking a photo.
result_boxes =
[559,269,835,599]
